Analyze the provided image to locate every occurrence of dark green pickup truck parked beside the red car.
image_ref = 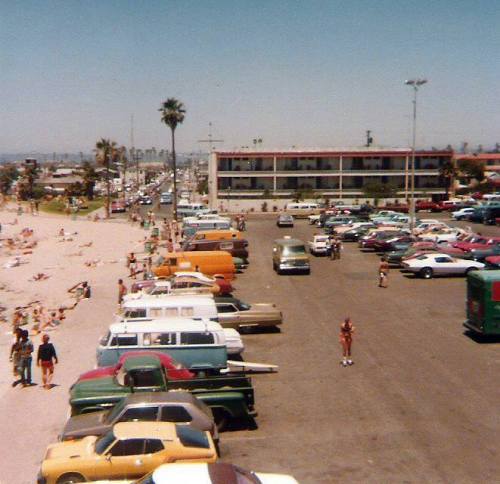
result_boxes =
[69,355,257,430]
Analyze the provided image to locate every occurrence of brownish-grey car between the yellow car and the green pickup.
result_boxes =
[59,391,219,443]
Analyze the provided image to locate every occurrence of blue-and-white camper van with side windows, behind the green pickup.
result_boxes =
[97,318,241,370]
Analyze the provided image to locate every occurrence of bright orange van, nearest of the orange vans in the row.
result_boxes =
[153,250,236,280]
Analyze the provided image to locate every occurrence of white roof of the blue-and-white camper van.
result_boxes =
[109,318,222,334]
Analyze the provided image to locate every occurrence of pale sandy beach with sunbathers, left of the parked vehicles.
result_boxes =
[0,211,146,484]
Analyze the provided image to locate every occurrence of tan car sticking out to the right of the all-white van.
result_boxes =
[215,297,283,330]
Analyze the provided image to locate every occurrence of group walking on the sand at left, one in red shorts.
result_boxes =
[10,328,59,390]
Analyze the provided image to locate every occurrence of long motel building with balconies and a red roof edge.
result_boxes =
[208,147,453,208]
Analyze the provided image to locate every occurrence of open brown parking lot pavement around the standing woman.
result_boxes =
[221,218,500,483]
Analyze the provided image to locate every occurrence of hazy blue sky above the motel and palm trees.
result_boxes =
[0,0,500,153]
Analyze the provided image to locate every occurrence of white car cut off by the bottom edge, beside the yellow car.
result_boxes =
[135,462,298,484]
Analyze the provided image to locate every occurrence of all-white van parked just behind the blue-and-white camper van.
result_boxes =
[118,294,218,321]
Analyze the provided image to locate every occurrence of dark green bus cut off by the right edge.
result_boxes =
[464,271,500,335]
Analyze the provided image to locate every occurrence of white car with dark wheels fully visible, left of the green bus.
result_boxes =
[403,253,485,279]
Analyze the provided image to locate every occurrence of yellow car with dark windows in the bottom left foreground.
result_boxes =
[38,422,217,484]
